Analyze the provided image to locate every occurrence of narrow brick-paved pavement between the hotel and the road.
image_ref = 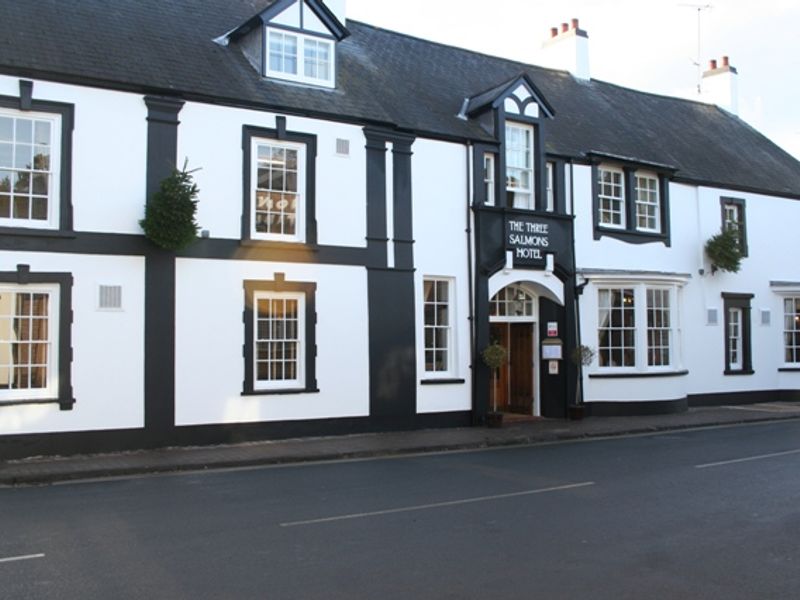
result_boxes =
[0,402,800,486]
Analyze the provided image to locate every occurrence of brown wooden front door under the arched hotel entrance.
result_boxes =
[489,323,533,415]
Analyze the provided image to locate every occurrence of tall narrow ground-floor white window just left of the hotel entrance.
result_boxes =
[423,277,455,375]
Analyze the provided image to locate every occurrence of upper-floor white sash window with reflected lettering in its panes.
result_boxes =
[250,138,306,241]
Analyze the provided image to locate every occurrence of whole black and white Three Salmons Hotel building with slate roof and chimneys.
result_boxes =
[0,0,800,458]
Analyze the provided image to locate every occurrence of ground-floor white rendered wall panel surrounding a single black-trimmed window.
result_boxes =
[175,259,369,425]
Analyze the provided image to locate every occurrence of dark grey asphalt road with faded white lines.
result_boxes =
[0,421,800,600]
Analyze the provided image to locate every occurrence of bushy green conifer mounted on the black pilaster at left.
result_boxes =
[139,163,200,251]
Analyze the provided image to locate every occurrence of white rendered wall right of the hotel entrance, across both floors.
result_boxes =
[574,159,800,402]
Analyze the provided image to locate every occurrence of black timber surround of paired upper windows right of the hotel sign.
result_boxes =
[587,157,676,247]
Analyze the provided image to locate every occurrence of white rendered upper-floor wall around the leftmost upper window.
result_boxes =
[0,75,147,234]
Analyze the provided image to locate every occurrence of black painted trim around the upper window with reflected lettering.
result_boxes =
[242,124,317,247]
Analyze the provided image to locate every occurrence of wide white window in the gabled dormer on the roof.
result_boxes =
[265,27,336,87]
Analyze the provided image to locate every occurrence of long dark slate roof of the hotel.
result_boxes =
[0,0,800,197]
